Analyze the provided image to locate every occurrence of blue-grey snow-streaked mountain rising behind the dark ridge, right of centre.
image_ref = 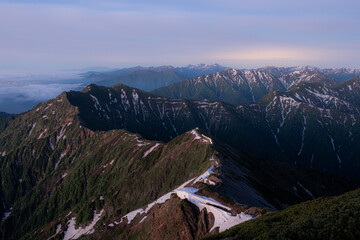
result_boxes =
[152,69,333,104]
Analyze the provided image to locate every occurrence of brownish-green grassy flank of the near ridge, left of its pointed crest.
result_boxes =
[2,130,214,239]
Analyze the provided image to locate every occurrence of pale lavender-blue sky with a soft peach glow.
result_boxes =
[0,0,360,71]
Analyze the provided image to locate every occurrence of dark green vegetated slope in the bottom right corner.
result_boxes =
[206,189,360,240]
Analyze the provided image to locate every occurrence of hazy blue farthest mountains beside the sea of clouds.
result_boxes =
[82,64,226,91]
